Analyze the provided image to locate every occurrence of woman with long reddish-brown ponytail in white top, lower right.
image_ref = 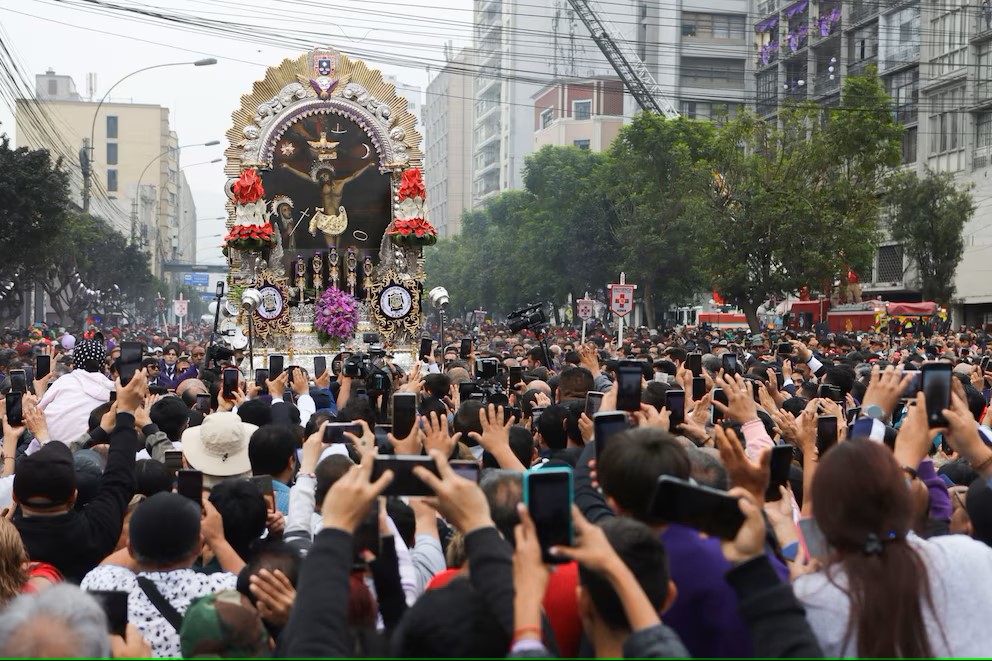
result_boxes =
[795,439,992,657]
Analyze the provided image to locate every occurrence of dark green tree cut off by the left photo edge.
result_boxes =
[0,135,70,282]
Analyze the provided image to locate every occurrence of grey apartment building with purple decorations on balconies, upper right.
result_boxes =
[752,0,992,325]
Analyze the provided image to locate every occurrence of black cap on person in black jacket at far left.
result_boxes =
[14,441,76,507]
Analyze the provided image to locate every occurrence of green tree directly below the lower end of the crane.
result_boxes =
[602,113,714,321]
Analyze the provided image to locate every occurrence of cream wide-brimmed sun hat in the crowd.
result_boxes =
[182,411,258,477]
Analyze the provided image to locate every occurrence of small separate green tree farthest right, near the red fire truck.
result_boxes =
[886,169,975,305]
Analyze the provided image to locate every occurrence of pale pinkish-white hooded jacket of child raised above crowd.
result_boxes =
[39,369,114,445]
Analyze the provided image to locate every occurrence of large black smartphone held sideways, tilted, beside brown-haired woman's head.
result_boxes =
[651,475,744,539]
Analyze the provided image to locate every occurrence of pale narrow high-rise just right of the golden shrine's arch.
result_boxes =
[424,51,474,237]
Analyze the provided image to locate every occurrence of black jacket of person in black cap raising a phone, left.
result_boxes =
[14,413,140,583]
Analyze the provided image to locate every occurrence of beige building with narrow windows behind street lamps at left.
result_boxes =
[15,76,179,274]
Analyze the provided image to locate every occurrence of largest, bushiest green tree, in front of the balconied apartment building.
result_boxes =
[700,72,902,331]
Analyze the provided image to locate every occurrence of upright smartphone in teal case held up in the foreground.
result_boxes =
[524,468,575,564]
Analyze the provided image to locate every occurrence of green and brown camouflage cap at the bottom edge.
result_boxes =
[179,590,269,659]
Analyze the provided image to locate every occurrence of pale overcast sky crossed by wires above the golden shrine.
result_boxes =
[0,0,472,263]
